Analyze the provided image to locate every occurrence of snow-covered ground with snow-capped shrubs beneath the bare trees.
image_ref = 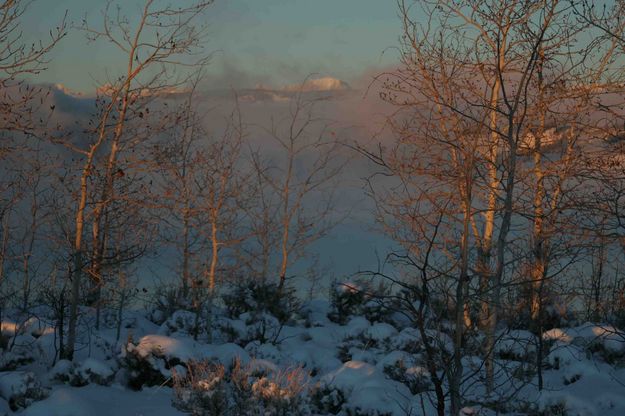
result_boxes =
[0,294,625,416]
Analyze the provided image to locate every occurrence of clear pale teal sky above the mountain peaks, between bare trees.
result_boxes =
[25,0,401,93]
